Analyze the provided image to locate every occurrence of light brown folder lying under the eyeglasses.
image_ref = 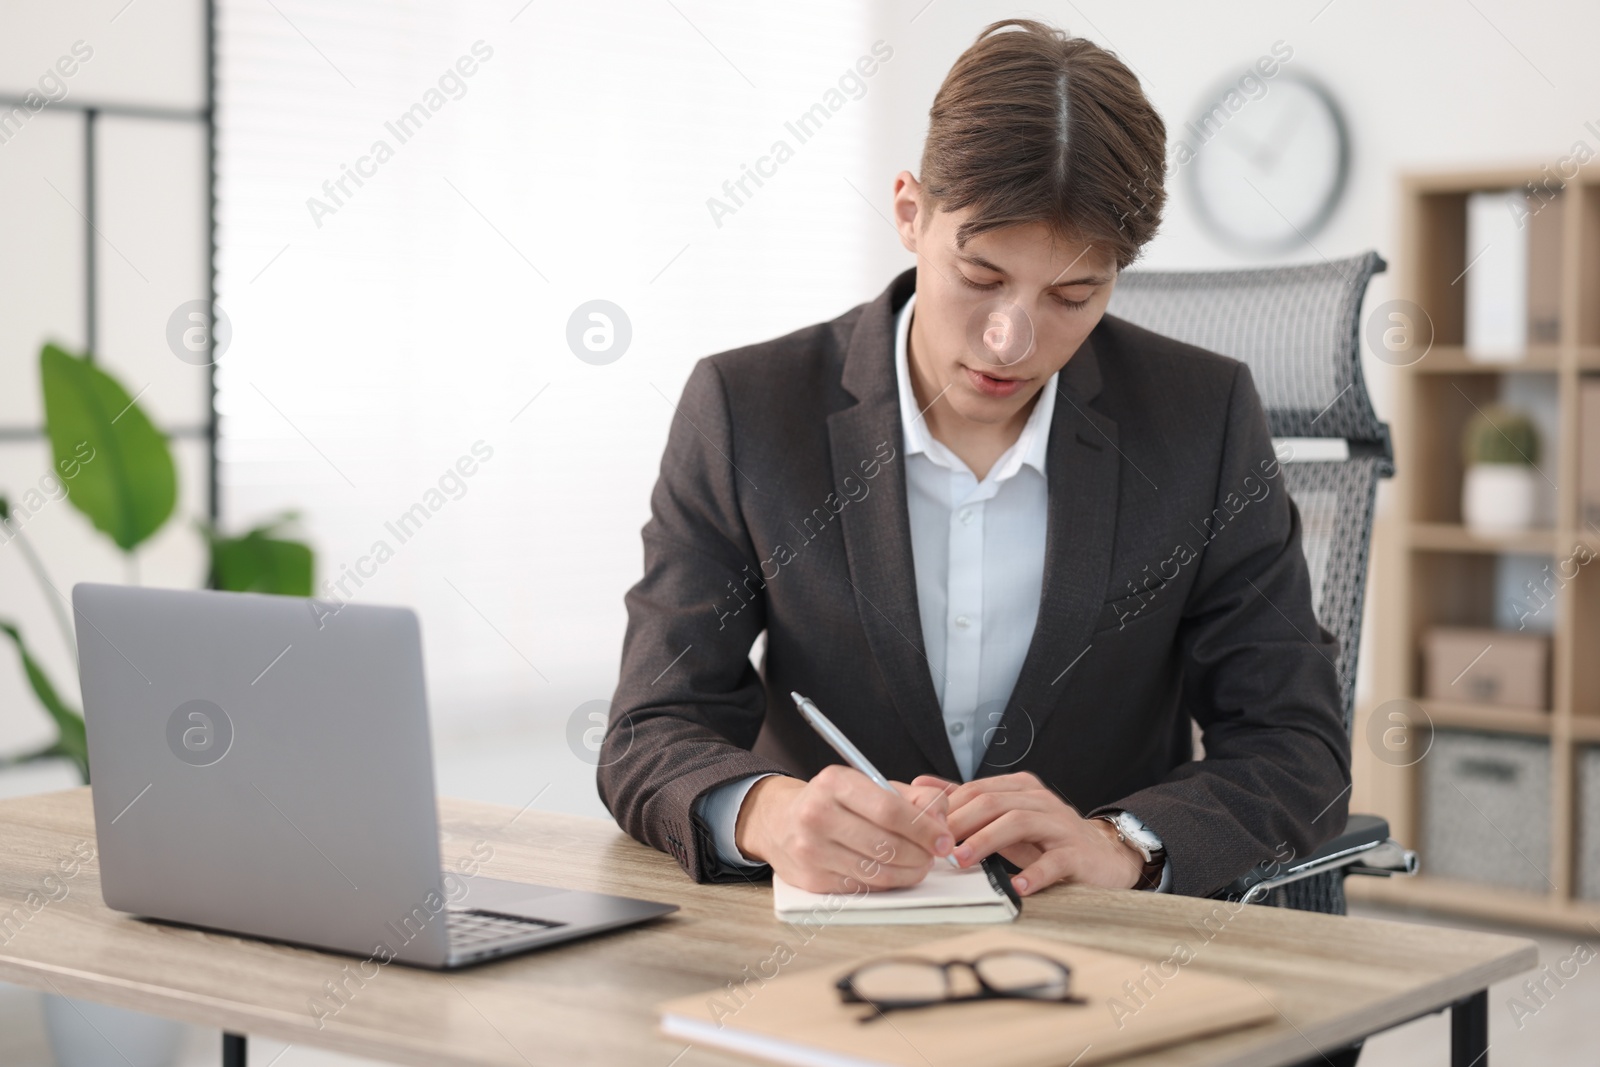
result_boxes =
[661,929,1277,1067]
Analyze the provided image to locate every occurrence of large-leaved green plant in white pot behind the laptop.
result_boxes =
[0,344,314,1067]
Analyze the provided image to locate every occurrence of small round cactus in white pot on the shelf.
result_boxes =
[1461,405,1539,534]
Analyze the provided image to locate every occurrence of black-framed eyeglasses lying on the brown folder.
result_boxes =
[834,949,1088,1022]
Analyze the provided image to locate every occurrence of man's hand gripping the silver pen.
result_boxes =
[734,763,955,894]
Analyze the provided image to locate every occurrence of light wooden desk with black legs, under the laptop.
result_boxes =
[0,789,1538,1067]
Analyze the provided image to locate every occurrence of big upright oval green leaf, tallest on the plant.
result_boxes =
[38,344,178,552]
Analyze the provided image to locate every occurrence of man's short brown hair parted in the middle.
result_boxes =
[922,19,1166,270]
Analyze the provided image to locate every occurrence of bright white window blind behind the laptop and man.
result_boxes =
[218,0,893,726]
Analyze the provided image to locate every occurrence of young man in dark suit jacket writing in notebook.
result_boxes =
[598,19,1350,894]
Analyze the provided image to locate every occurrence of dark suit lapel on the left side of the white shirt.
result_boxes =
[827,270,960,781]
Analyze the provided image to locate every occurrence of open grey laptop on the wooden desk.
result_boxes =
[72,584,677,968]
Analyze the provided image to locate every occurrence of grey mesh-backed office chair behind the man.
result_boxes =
[1107,251,1418,915]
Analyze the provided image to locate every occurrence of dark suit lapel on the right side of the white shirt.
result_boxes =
[974,331,1122,777]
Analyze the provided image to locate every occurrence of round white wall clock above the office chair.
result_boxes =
[1182,70,1349,251]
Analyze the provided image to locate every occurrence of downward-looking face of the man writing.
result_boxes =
[894,174,1117,426]
